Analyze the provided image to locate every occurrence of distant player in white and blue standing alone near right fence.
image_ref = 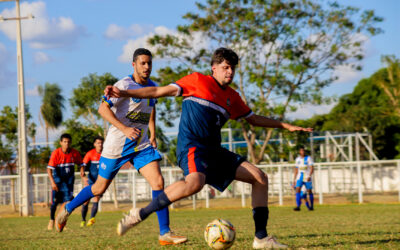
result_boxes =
[293,147,314,211]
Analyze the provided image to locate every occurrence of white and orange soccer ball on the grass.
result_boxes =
[204,219,236,249]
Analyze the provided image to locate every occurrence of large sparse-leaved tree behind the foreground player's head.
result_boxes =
[148,0,382,163]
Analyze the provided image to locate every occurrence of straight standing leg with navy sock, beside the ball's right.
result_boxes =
[235,161,287,249]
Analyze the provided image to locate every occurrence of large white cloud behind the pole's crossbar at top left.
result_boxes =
[0,1,86,49]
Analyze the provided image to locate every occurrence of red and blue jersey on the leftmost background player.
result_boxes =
[47,148,82,183]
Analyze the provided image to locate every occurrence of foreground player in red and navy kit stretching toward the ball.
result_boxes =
[105,48,312,249]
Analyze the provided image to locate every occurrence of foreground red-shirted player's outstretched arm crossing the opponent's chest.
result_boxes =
[104,85,180,99]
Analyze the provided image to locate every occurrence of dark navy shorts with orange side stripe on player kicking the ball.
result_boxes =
[178,146,246,192]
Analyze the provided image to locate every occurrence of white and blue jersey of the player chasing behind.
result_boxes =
[101,75,157,159]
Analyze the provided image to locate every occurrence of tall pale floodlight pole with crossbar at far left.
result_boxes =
[0,0,33,216]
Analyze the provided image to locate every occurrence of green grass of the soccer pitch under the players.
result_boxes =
[0,204,400,249]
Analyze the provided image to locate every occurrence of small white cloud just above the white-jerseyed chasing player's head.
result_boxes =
[104,24,154,40]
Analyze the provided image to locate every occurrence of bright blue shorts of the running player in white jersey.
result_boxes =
[99,146,161,180]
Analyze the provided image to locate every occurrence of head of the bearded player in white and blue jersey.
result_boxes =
[132,48,153,81]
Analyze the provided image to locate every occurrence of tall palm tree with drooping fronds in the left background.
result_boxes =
[38,82,65,144]
